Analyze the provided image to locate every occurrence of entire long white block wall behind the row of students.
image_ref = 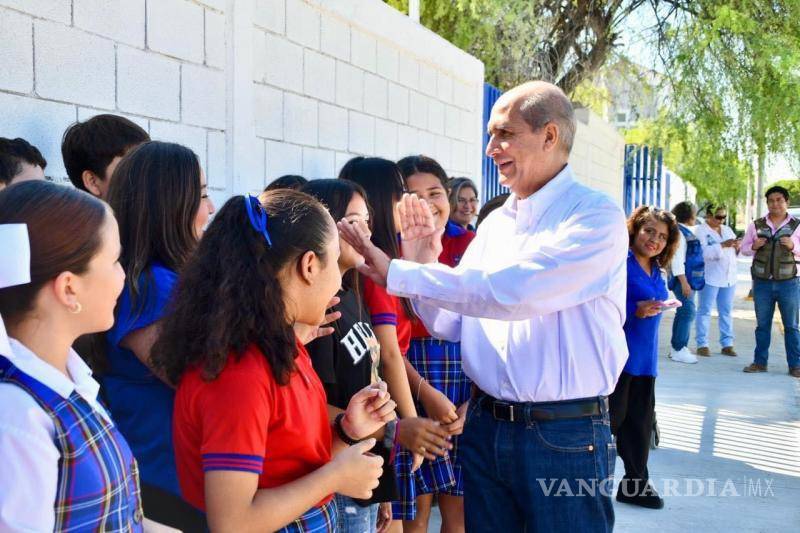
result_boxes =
[0,0,483,206]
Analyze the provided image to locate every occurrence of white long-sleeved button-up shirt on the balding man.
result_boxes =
[388,166,628,402]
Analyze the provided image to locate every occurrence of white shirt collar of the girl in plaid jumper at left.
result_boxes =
[4,338,100,401]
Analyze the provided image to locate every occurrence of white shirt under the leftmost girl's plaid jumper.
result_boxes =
[0,338,110,531]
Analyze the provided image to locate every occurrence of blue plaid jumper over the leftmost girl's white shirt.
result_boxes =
[0,357,143,532]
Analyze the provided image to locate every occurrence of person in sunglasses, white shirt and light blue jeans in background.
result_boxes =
[695,205,741,357]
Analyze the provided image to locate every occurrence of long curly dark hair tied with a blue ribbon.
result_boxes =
[152,189,334,384]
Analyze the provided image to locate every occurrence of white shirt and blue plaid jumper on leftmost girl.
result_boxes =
[0,339,143,532]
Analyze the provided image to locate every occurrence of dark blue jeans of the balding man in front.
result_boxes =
[460,400,617,533]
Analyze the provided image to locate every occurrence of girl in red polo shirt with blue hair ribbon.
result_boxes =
[153,190,395,532]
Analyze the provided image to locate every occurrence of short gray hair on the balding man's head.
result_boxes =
[519,86,577,154]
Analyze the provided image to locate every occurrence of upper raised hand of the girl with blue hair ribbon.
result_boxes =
[342,381,397,440]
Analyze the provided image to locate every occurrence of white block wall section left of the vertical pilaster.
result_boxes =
[0,0,227,204]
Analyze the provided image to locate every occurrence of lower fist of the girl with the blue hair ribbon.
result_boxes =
[331,439,383,500]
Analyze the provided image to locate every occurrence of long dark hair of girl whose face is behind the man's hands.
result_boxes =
[339,156,416,319]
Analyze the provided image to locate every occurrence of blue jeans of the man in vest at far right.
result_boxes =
[753,278,800,368]
